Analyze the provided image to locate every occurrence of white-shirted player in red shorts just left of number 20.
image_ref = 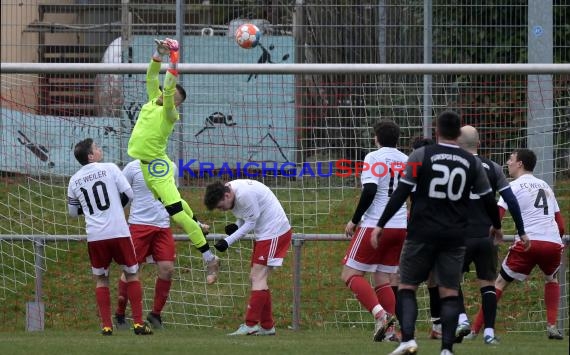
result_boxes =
[341,121,408,341]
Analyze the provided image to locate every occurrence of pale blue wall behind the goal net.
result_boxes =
[0,36,295,175]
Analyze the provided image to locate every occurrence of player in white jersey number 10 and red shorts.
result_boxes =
[67,138,152,335]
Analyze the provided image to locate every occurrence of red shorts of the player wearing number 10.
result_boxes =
[87,237,139,276]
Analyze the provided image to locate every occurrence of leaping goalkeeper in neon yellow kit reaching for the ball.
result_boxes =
[128,38,219,284]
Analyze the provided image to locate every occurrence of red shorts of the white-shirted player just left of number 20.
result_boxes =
[342,227,407,274]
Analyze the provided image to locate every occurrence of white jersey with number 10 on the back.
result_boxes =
[67,163,131,242]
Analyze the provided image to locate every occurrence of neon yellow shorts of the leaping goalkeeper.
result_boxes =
[141,157,182,206]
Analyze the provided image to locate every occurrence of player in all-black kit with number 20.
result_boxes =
[371,111,502,355]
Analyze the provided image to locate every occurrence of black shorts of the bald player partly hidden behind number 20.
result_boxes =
[463,237,499,281]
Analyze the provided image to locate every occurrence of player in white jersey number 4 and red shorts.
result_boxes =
[466,149,564,339]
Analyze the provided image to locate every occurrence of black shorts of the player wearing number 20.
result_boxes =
[400,239,465,290]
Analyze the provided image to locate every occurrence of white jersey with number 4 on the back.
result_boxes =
[498,174,562,244]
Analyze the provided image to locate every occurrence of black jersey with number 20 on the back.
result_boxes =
[400,144,491,244]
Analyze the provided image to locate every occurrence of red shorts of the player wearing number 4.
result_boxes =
[502,240,564,281]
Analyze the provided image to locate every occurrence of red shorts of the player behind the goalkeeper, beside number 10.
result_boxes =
[129,224,176,263]
